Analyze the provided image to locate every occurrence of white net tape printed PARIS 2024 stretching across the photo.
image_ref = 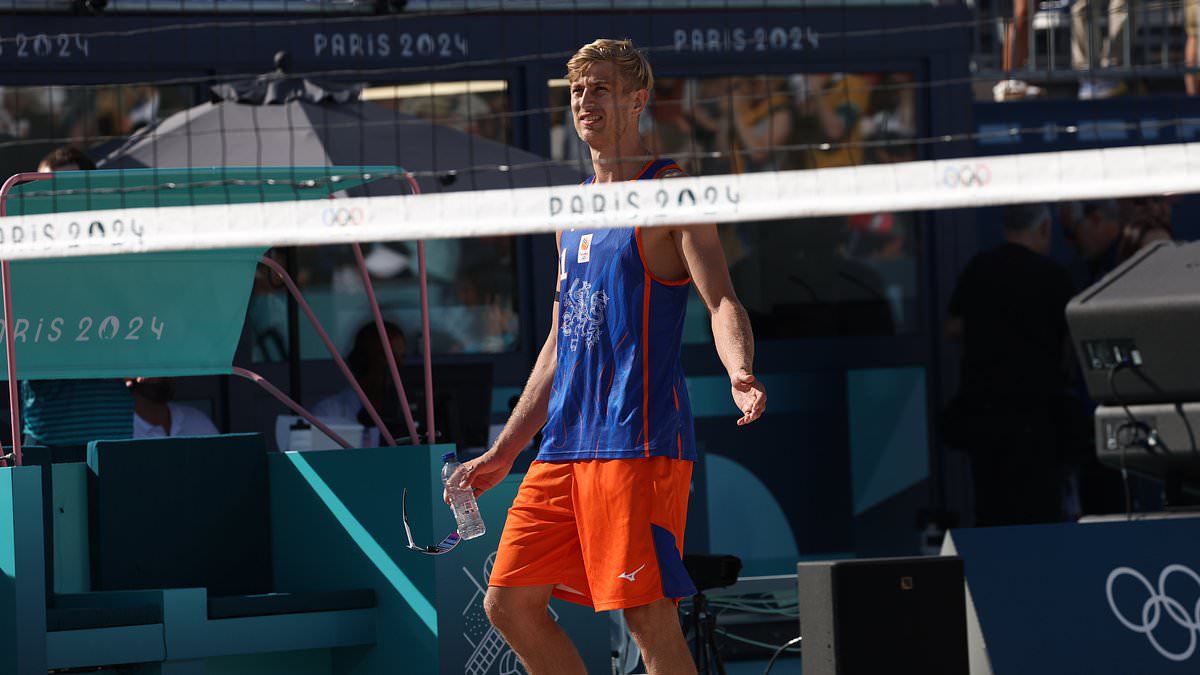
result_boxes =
[0,143,1200,259]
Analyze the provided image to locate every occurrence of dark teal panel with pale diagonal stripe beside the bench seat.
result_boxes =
[270,446,450,675]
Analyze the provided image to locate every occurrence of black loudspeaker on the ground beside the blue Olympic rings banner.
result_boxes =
[796,556,968,675]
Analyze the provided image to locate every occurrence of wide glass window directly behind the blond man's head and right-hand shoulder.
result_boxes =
[550,72,919,342]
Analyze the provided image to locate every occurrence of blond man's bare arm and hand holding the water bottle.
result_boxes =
[460,238,559,496]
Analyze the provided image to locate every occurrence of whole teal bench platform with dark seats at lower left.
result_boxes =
[0,435,610,675]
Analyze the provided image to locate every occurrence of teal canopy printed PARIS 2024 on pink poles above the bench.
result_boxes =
[0,166,403,380]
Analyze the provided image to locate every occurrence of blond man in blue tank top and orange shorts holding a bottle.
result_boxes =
[451,40,766,675]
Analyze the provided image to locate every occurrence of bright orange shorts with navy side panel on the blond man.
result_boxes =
[488,456,696,611]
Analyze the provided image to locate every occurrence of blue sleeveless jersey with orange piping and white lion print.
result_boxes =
[538,160,696,461]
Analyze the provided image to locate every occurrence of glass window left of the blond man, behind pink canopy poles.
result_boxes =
[248,80,518,360]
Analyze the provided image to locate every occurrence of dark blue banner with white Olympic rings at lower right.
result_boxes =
[948,518,1200,675]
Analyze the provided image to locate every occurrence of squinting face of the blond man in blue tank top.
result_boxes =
[571,61,647,150]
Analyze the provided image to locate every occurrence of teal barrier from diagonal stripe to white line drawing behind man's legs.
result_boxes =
[270,446,611,675]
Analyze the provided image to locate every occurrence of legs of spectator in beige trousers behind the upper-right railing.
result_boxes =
[1070,0,1130,100]
